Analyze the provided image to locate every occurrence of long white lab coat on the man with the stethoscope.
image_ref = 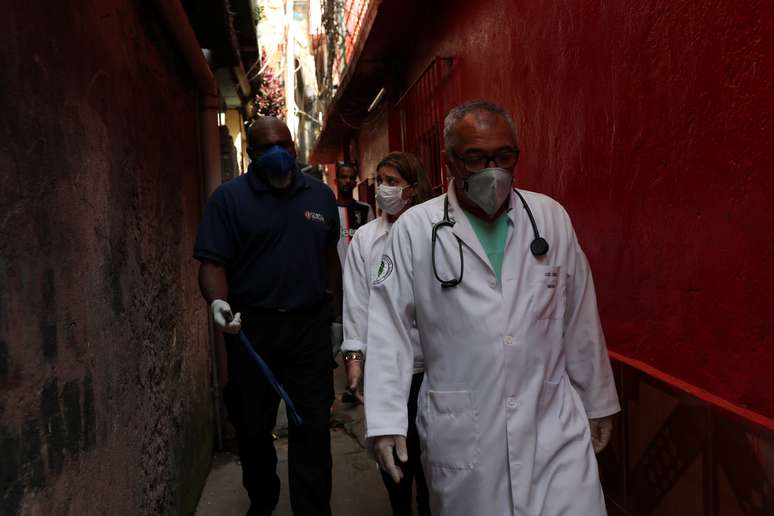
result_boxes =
[365,187,620,516]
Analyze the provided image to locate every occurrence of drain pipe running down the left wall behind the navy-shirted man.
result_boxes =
[154,0,225,449]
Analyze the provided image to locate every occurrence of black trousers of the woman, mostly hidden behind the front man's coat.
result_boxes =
[379,373,430,516]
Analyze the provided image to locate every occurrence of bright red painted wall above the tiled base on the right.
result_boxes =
[398,0,774,417]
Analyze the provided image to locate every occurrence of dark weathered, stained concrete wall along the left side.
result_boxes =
[0,0,212,516]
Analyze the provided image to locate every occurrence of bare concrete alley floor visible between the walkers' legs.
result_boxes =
[196,367,400,516]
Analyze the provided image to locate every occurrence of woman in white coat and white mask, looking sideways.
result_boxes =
[341,152,430,516]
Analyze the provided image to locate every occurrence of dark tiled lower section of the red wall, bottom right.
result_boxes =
[598,360,774,516]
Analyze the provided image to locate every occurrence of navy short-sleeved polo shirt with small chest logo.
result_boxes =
[194,167,340,310]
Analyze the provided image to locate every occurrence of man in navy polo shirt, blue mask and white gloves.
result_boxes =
[194,117,341,516]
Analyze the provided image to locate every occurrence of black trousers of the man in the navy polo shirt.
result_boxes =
[223,304,334,516]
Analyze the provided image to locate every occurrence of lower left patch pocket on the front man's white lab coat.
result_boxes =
[425,391,481,469]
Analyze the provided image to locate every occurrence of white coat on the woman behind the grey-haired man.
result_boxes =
[341,215,424,373]
